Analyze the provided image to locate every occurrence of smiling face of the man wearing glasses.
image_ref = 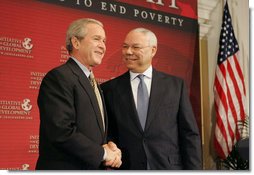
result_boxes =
[122,31,157,73]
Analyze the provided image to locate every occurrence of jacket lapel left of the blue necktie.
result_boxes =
[116,72,143,132]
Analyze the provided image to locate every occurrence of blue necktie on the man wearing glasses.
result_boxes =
[137,74,149,130]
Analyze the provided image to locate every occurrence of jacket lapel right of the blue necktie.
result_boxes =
[145,69,165,130]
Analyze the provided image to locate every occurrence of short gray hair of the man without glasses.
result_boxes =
[65,18,103,53]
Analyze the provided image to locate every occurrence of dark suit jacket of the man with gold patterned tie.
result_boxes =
[36,59,107,170]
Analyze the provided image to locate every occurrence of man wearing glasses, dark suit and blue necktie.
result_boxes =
[101,28,202,170]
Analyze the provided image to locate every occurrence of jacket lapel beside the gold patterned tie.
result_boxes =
[67,59,106,137]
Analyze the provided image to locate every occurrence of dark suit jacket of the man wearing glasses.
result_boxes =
[101,70,201,170]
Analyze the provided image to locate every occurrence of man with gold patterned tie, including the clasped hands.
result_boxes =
[36,18,121,170]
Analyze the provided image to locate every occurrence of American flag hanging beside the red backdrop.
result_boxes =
[214,2,246,159]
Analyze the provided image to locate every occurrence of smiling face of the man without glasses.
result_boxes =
[71,23,106,69]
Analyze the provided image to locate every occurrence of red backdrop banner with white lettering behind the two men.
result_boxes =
[0,0,200,170]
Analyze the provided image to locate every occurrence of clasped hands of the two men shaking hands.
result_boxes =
[102,141,122,168]
